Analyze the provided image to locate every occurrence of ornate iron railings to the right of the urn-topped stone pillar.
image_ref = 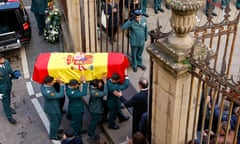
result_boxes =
[186,5,240,144]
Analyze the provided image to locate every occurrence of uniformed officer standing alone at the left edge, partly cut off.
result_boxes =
[0,53,18,124]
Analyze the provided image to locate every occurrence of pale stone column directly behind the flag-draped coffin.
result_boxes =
[67,0,97,52]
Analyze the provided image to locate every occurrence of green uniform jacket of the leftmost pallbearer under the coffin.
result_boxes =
[41,84,64,115]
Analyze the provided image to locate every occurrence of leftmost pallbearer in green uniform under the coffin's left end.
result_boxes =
[41,76,64,140]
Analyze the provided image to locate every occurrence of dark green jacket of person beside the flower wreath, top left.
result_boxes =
[31,0,48,14]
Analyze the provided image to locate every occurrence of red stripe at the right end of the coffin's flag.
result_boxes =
[107,53,129,82]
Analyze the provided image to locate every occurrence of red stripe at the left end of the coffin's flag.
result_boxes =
[32,53,51,84]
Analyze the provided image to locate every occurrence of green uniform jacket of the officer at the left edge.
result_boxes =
[0,60,13,96]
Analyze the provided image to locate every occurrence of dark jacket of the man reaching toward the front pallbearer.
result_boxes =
[121,89,148,133]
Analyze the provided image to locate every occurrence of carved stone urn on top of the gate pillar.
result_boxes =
[167,0,205,51]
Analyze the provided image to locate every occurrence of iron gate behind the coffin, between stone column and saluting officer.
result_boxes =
[96,0,140,54]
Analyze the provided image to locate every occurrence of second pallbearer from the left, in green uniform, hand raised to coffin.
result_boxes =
[66,76,88,135]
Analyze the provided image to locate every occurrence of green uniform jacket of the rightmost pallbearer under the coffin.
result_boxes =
[107,79,129,108]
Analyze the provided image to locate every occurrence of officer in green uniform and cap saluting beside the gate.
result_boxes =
[122,9,148,72]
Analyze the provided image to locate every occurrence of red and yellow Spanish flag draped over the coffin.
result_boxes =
[32,52,129,84]
